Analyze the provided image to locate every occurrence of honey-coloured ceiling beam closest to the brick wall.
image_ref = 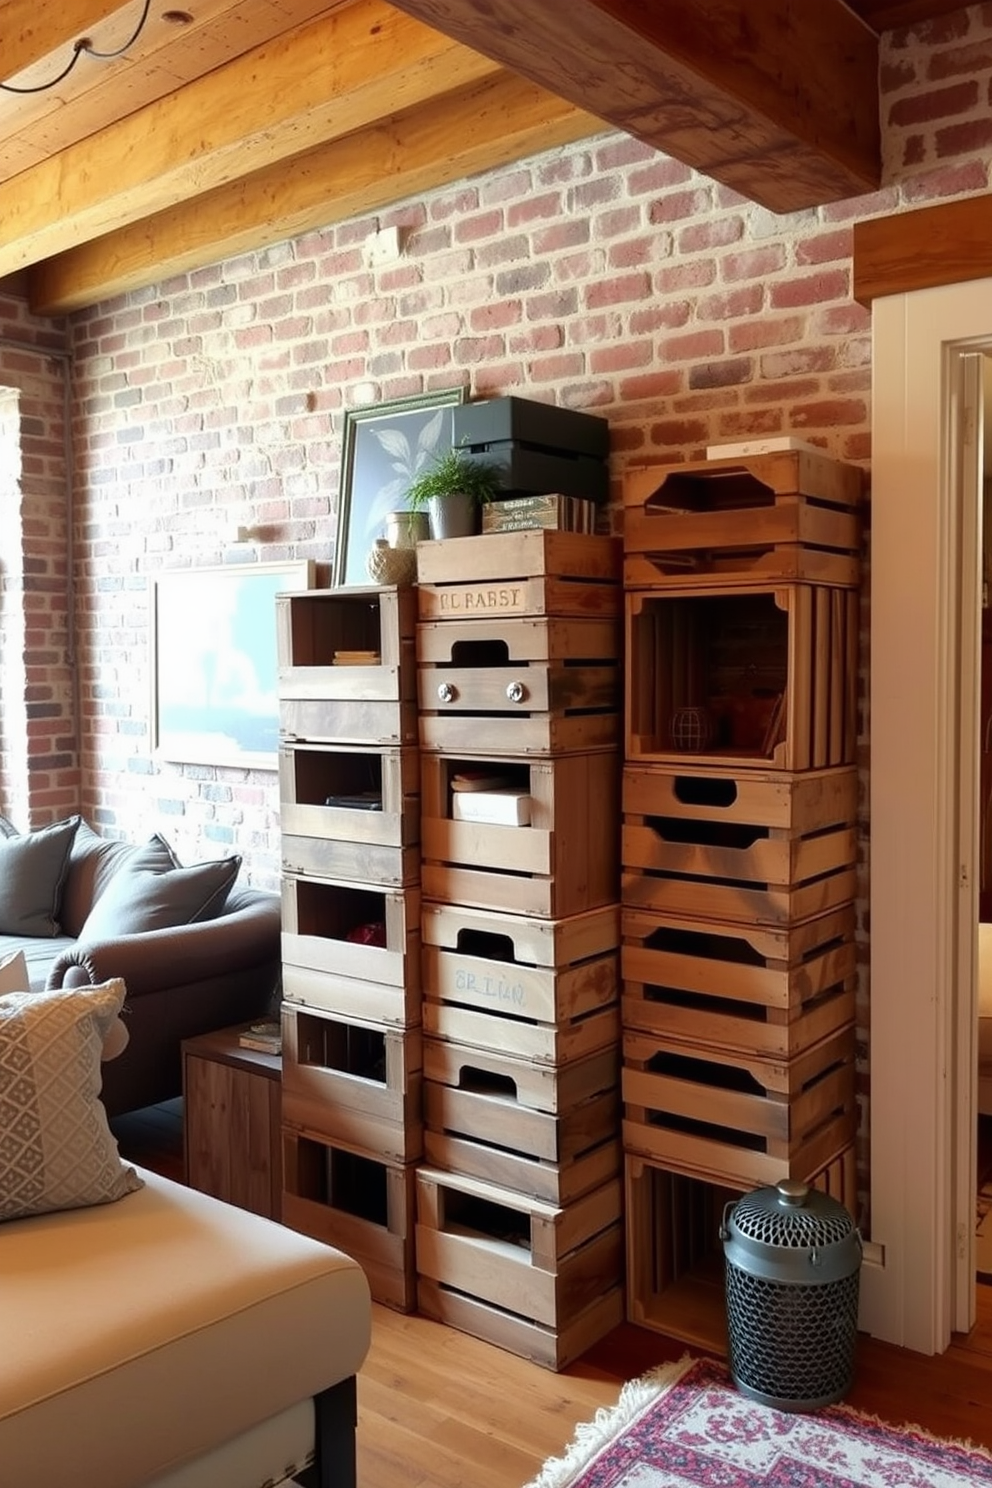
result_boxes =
[28,73,602,314]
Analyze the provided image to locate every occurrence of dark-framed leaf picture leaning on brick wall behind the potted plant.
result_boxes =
[333,387,467,585]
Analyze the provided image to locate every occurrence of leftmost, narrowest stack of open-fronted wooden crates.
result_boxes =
[277,588,422,1311]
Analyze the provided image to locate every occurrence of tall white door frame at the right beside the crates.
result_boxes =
[861,280,992,1354]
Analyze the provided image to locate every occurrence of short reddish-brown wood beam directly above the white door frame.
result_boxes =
[854,196,992,305]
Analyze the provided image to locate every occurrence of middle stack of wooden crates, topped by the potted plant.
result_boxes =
[416,530,623,1369]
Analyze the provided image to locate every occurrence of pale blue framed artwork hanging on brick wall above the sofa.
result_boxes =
[149,559,314,769]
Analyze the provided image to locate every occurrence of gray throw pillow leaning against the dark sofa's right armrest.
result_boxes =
[79,856,241,943]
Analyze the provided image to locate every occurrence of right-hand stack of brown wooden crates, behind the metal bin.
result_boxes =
[622,449,861,1347]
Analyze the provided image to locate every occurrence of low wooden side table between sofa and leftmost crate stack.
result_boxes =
[183,1024,283,1220]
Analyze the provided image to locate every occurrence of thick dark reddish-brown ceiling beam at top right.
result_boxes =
[383,0,880,211]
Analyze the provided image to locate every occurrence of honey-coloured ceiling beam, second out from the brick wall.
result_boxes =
[0,0,498,277]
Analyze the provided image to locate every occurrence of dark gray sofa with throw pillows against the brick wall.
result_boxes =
[0,817,281,1116]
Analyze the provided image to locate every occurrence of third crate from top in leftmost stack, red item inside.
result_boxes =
[283,873,421,1027]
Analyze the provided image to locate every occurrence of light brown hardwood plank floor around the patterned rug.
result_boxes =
[113,1103,992,1488]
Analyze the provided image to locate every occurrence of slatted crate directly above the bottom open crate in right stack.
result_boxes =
[622,1028,858,1186]
